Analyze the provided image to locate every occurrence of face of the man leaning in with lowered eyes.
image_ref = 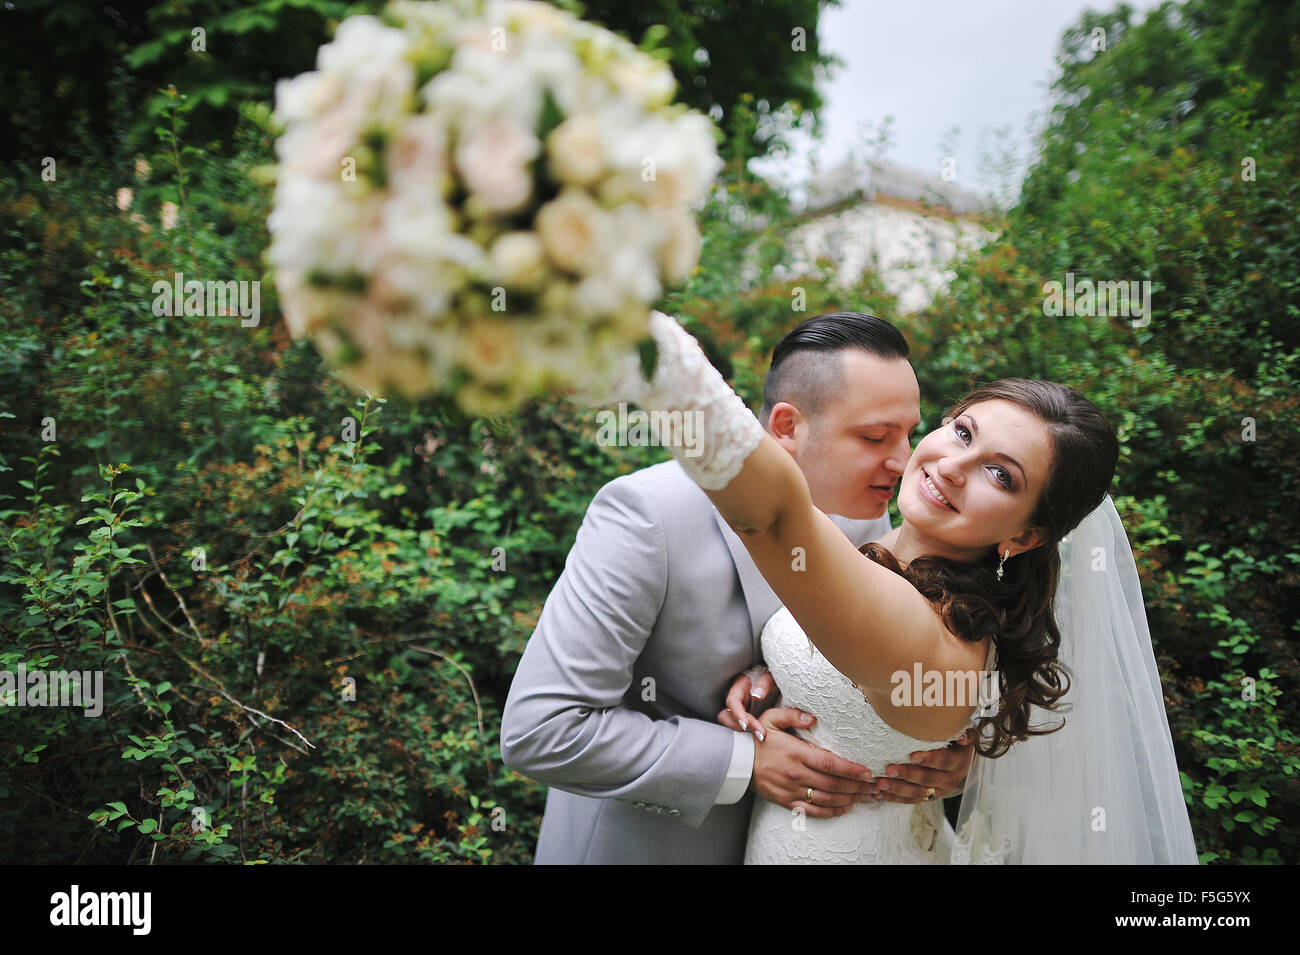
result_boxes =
[771,348,920,520]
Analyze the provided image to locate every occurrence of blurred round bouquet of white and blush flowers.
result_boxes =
[269,0,722,413]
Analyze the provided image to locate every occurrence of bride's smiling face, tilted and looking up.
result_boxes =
[898,399,1052,561]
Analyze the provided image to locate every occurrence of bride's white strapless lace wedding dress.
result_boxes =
[745,607,992,865]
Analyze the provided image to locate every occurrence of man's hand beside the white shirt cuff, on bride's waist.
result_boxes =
[750,707,871,819]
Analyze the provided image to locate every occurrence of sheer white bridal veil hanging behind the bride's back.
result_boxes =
[952,495,1197,864]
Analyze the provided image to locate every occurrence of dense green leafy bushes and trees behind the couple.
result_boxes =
[0,0,1300,864]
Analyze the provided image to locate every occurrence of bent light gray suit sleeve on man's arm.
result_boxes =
[501,477,735,828]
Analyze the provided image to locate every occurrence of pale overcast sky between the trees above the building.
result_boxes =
[754,0,1158,205]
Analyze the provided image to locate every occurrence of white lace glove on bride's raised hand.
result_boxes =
[575,312,763,491]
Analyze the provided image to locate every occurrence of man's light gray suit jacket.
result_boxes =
[501,461,889,864]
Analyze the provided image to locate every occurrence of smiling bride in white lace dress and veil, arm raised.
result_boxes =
[590,312,1196,864]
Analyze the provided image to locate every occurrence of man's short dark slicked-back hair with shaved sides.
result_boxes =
[759,312,911,427]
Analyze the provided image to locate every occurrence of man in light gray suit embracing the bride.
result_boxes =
[501,312,970,864]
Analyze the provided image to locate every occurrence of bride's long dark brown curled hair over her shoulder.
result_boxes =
[862,378,1119,758]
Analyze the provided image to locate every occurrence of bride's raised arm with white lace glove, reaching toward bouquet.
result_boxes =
[603,312,959,694]
